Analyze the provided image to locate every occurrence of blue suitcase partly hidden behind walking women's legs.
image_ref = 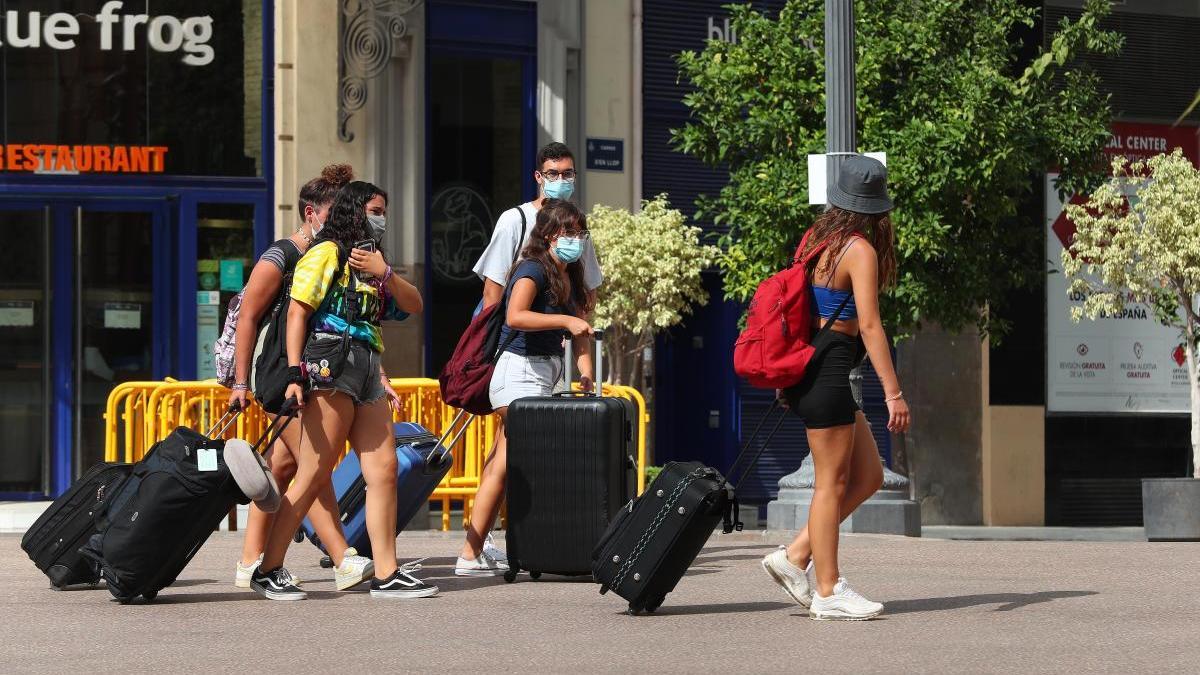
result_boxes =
[296,412,474,554]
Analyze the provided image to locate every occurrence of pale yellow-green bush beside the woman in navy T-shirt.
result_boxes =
[588,195,716,386]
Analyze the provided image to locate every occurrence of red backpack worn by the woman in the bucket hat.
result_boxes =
[733,231,854,389]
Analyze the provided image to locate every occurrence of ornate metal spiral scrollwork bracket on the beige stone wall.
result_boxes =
[337,0,421,143]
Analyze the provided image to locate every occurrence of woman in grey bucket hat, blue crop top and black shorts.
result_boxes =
[762,155,910,621]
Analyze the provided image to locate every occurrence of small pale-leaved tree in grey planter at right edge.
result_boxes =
[1062,150,1200,540]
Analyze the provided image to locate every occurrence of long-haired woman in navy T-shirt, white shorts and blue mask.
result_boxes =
[455,199,594,577]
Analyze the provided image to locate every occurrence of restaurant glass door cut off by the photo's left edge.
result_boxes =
[0,203,52,498]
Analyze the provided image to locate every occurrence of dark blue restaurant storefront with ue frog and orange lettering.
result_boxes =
[0,0,275,500]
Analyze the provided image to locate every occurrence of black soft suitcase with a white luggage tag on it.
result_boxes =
[83,406,295,604]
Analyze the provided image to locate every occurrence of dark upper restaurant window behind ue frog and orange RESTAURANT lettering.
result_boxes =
[0,0,264,177]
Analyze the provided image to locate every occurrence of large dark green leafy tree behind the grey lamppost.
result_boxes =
[673,0,1121,334]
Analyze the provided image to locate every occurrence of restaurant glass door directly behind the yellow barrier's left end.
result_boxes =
[71,203,170,476]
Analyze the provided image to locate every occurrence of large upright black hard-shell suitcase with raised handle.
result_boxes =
[504,330,636,581]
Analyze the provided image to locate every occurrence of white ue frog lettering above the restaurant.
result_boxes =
[0,0,215,66]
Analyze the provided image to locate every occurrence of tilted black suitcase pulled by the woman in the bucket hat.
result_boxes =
[592,398,786,614]
